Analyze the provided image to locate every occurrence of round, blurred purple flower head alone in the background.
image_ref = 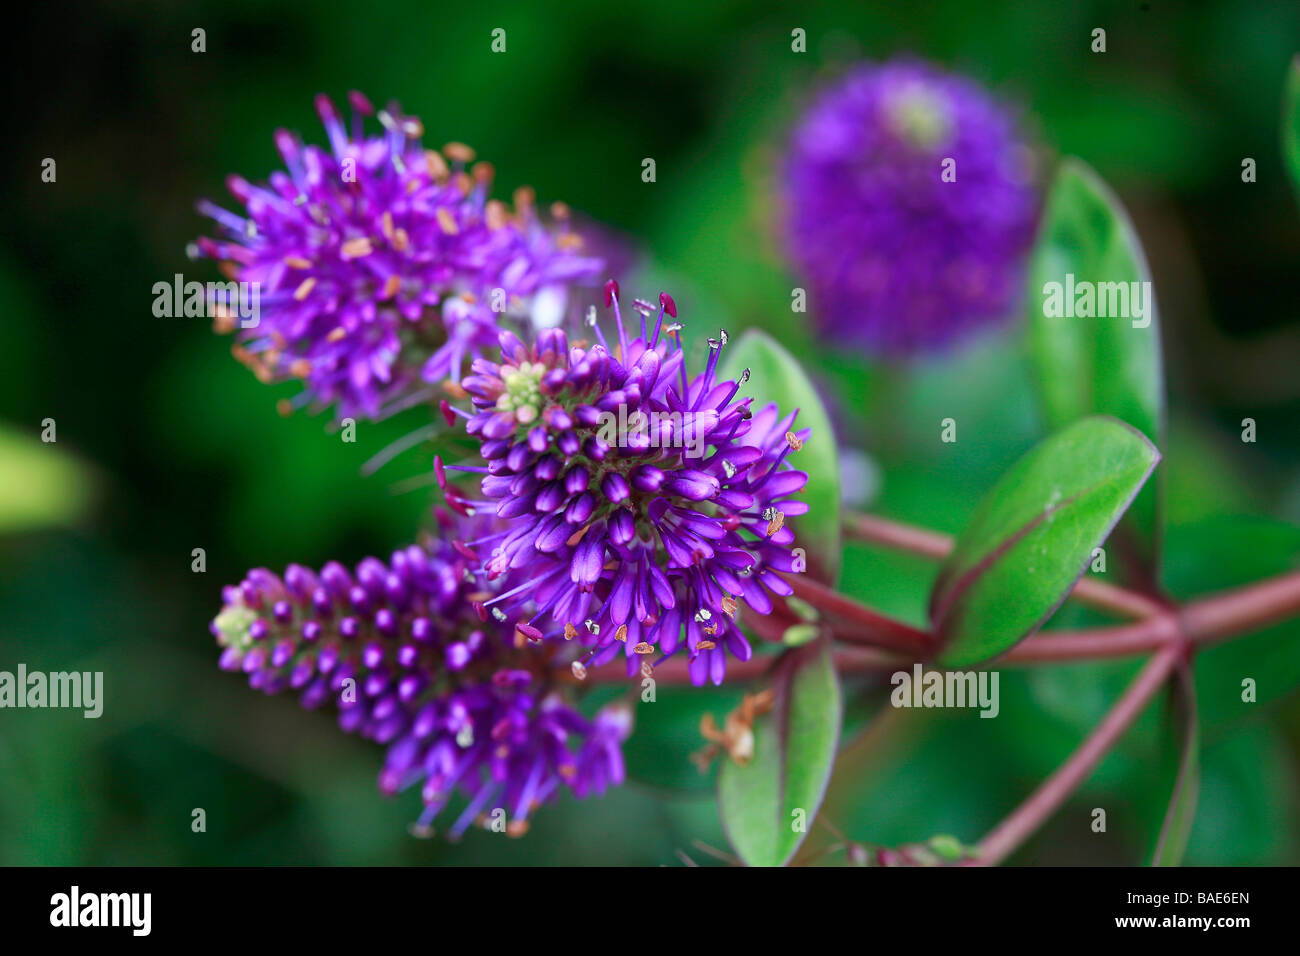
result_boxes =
[783,61,1037,354]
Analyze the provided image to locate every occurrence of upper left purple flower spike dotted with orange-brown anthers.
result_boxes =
[196,92,601,418]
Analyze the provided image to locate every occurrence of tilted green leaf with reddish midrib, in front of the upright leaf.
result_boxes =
[930,416,1160,667]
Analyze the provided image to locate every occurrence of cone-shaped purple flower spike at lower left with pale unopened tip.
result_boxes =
[212,515,629,836]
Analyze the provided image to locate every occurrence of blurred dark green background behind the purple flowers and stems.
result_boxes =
[0,0,1300,865]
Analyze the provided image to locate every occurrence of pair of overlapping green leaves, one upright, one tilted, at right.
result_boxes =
[930,159,1165,667]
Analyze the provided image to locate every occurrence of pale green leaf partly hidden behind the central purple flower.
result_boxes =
[719,329,840,584]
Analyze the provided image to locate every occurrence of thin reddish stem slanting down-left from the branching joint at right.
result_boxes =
[976,641,1184,866]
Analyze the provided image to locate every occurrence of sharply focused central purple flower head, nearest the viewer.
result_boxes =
[436,282,807,684]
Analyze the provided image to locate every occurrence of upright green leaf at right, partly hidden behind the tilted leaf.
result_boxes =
[1027,157,1165,581]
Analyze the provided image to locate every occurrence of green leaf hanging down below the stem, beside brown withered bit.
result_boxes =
[718,641,841,866]
